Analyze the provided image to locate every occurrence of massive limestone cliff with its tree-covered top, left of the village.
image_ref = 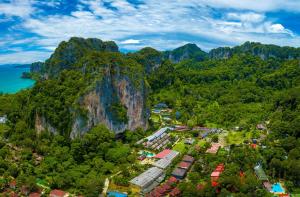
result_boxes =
[32,38,148,138]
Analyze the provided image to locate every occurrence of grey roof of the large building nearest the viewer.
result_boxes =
[129,167,164,188]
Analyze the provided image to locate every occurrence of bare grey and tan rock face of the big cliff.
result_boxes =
[71,64,147,137]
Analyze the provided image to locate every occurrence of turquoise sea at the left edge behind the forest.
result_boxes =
[0,64,35,94]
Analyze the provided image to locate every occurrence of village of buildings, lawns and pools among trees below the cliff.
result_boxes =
[0,103,289,197]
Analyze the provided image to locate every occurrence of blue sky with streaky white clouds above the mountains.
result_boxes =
[0,0,300,64]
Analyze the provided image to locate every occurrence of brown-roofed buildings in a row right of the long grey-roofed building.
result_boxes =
[171,155,195,180]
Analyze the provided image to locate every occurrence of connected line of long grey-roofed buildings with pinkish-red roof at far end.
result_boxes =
[129,149,179,194]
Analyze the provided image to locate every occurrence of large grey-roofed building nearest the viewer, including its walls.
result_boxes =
[129,167,165,194]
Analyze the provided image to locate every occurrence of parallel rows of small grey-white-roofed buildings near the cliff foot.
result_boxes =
[136,127,172,150]
